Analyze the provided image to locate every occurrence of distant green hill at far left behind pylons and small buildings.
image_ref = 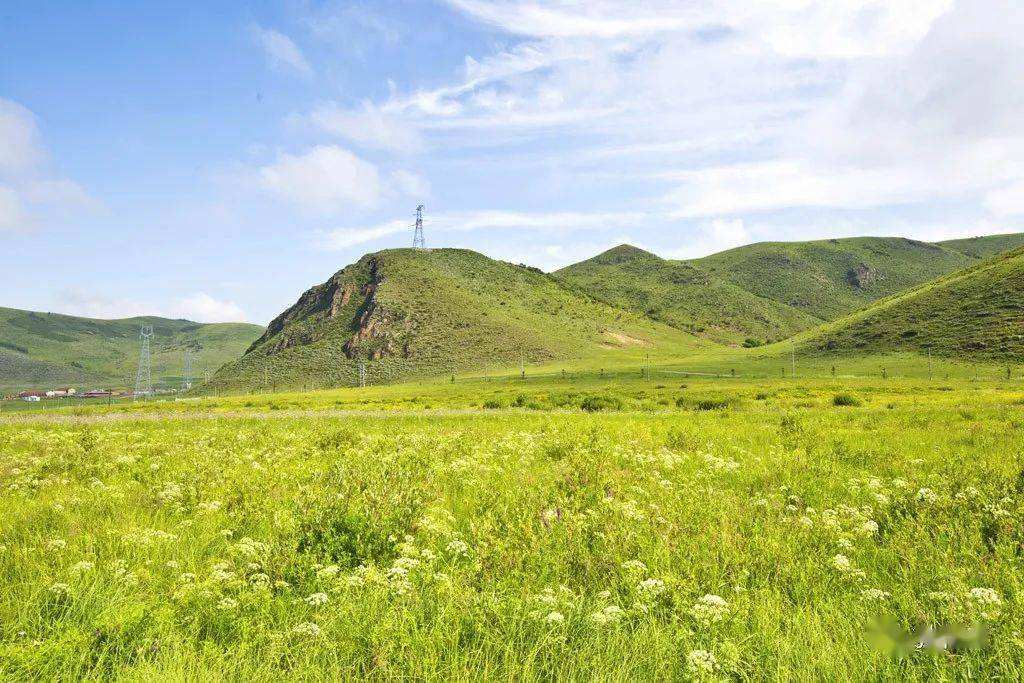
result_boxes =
[0,308,263,391]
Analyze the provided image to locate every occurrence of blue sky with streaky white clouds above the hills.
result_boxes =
[0,0,1024,324]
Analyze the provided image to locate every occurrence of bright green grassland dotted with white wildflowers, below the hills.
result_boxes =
[0,365,1024,680]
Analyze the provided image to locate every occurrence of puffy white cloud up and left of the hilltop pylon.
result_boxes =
[258,145,384,214]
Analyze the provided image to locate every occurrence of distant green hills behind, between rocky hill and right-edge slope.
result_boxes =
[555,233,1024,343]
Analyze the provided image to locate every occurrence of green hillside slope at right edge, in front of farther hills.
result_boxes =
[797,248,1024,361]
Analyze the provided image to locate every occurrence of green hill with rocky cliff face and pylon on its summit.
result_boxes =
[206,249,701,391]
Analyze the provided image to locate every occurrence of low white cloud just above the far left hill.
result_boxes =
[56,288,246,323]
